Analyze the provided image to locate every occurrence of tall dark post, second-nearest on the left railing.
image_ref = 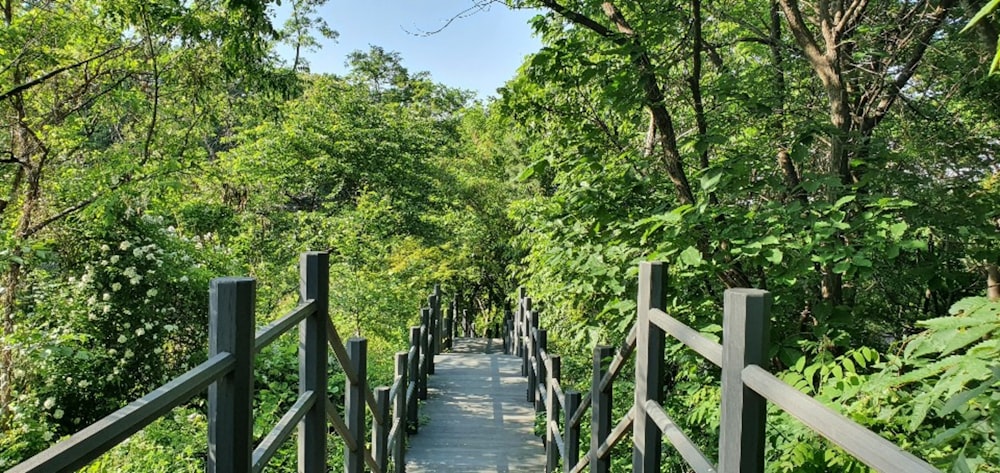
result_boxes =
[298,251,330,473]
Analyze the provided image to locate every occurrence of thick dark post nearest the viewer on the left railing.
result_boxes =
[207,278,257,473]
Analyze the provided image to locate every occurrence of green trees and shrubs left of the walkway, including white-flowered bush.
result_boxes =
[0,0,514,472]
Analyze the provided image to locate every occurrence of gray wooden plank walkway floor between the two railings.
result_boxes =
[406,338,545,473]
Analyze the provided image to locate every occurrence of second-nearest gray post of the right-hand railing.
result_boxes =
[632,262,667,473]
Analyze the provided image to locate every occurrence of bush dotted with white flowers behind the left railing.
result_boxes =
[0,205,230,467]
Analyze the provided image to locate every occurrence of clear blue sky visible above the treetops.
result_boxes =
[275,0,541,98]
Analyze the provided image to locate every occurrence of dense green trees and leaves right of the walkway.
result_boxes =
[495,0,1000,472]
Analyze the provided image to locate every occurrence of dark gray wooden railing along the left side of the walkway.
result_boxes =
[8,252,441,473]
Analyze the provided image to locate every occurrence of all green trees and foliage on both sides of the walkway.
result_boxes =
[0,0,1000,472]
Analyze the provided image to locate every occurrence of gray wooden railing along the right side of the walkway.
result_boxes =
[504,263,939,473]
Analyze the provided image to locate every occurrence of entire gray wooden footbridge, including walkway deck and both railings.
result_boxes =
[8,252,938,473]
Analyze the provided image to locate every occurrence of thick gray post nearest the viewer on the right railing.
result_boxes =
[719,289,771,473]
